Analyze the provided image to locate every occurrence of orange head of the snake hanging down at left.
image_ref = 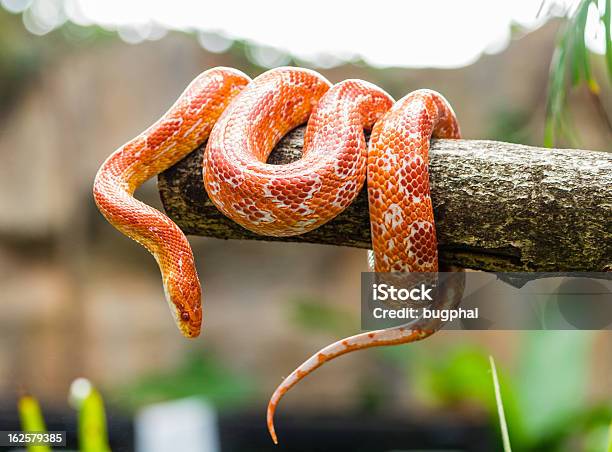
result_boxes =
[164,273,202,338]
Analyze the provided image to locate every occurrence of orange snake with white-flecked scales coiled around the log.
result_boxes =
[94,67,459,442]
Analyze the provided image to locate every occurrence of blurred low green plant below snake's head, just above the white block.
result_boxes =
[113,352,255,410]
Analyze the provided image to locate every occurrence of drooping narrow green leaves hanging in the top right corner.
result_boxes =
[544,0,612,147]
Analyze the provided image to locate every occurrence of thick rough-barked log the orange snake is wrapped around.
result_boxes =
[158,128,612,272]
